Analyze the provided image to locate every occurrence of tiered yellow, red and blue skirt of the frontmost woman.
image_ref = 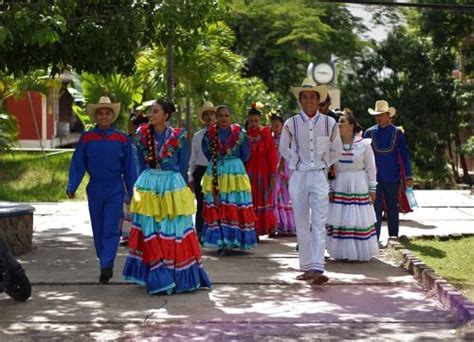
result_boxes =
[123,169,211,294]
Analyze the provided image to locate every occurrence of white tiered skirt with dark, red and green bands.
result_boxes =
[326,170,378,261]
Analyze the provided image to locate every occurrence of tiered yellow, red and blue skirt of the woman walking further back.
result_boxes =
[202,158,257,250]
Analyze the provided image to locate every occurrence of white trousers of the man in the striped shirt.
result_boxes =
[289,170,329,272]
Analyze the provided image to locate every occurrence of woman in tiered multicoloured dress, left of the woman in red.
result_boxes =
[202,106,257,255]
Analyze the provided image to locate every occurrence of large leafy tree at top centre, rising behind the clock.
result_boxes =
[227,0,366,106]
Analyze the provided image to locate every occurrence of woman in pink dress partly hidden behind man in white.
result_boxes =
[270,114,296,236]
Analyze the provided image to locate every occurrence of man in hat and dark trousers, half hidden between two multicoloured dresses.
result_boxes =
[188,101,216,240]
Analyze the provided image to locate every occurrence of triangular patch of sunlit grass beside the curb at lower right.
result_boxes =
[400,237,474,301]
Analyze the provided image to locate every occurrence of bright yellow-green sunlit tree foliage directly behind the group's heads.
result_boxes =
[137,22,278,128]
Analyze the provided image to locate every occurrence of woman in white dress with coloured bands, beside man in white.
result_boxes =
[326,110,378,261]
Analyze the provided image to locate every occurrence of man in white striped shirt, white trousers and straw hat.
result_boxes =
[279,78,342,284]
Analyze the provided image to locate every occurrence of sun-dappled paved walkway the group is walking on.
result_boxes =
[0,191,474,341]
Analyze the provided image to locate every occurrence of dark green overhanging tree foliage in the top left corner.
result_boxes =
[0,0,147,75]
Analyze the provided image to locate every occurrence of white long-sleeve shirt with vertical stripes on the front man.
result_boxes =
[279,111,342,171]
